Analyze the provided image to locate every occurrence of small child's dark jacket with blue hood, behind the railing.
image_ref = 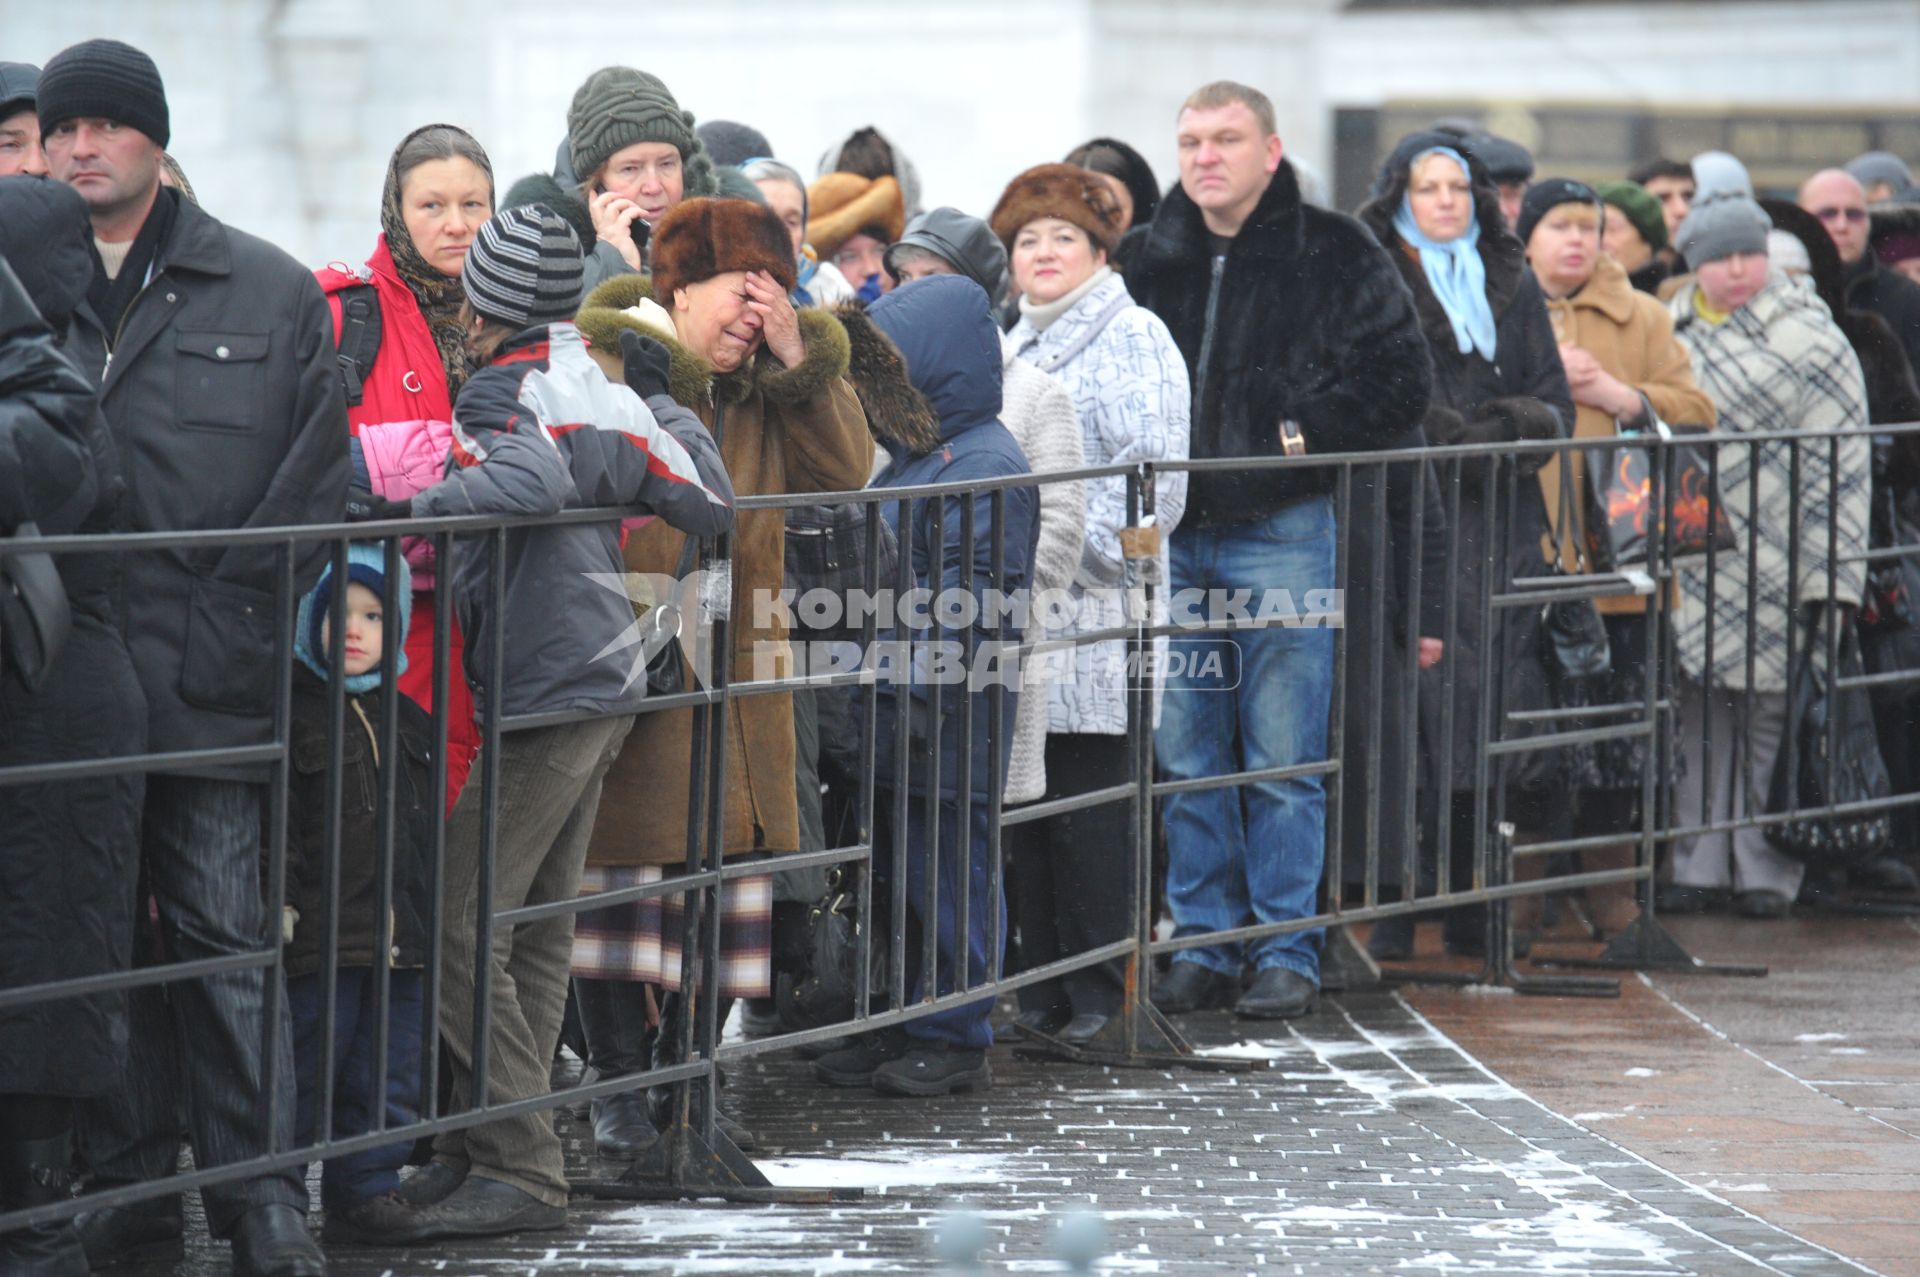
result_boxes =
[286,542,434,976]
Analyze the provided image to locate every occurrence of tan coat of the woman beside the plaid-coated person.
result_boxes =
[1540,255,1716,613]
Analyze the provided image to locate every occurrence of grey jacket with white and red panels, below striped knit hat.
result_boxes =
[413,325,733,714]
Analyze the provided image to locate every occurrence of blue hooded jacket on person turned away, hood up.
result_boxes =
[868,275,1041,801]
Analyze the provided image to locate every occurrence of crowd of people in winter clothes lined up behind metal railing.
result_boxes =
[0,40,1920,1277]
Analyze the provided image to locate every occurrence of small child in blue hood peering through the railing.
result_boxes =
[282,543,432,1242]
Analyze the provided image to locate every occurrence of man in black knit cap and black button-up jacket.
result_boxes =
[38,40,348,1277]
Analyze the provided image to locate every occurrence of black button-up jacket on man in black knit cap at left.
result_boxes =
[69,188,348,780]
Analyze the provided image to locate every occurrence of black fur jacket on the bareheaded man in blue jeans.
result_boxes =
[1127,161,1430,528]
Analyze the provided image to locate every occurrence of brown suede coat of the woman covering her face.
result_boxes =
[578,275,874,866]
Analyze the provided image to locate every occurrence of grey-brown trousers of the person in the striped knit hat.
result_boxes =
[434,714,634,1206]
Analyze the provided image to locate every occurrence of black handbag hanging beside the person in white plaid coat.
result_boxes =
[1766,610,1893,868]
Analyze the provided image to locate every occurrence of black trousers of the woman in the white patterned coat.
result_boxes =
[1002,734,1133,1016]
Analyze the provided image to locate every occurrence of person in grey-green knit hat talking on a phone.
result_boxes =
[566,67,720,292]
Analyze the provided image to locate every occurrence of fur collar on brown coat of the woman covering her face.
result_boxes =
[574,275,847,409]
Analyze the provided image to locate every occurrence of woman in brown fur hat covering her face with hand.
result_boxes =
[574,200,887,1158]
